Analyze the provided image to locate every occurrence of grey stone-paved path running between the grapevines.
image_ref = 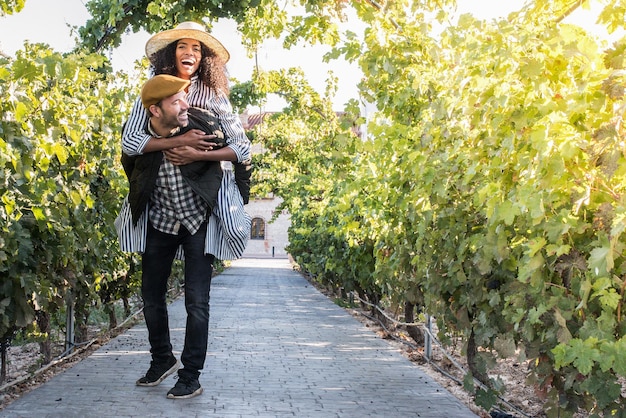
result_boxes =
[0,259,476,418]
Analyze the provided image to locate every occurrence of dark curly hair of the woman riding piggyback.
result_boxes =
[150,41,230,96]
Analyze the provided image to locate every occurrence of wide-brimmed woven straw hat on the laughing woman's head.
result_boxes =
[146,22,230,62]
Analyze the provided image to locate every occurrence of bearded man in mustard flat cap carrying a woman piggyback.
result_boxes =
[123,75,225,399]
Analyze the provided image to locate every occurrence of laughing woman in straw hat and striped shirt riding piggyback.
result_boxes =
[122,22,251,260]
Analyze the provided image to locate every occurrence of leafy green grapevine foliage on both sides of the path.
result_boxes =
[0,0,626,416]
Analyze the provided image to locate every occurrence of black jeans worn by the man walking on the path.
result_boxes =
[141,223,215,378]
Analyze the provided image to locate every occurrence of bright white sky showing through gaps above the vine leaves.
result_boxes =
[0,0,616,111]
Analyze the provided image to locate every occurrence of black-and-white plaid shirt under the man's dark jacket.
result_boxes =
[148,124,209,235]
